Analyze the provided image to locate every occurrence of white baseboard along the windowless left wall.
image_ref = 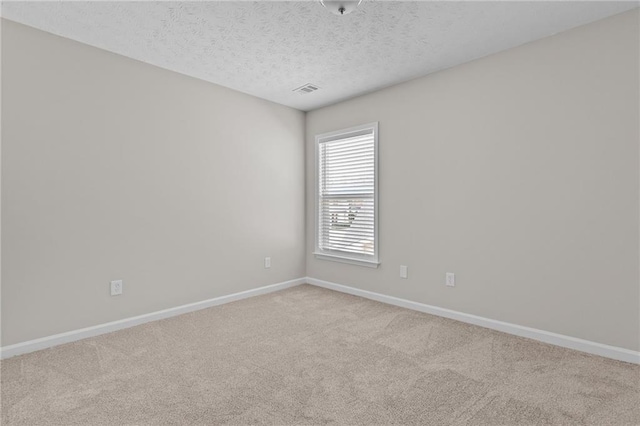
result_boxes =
[0,278,306,359]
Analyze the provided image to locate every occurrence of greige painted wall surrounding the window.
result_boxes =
[307,9,640,350]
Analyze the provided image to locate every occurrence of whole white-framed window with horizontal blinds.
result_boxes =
[315,123,378,267]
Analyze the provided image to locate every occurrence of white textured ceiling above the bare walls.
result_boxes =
[2,0,638,110]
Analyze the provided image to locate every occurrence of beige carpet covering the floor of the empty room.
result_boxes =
[1,285,640,426]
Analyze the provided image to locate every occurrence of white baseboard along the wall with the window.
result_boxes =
[307,277,640,364]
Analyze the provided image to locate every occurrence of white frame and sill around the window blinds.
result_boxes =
[313,121,380,268]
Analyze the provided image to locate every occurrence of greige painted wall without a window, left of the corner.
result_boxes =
[2,21,305,346]
